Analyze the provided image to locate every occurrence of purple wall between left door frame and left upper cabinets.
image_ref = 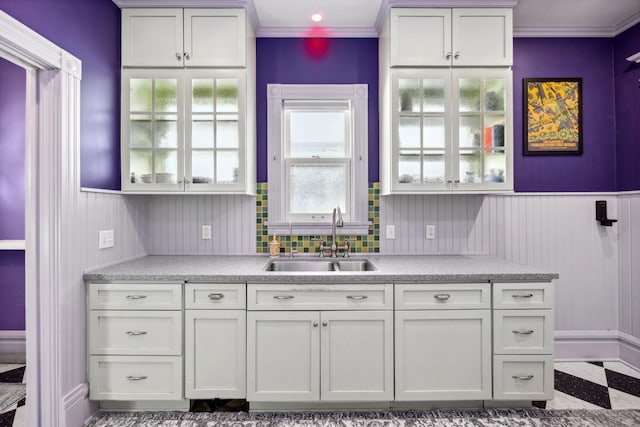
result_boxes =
[0,0,120,190]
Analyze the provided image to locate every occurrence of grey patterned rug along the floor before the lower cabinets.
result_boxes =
[85,409,640,427]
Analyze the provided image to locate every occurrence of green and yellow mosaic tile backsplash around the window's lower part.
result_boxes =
[256,182,380,254]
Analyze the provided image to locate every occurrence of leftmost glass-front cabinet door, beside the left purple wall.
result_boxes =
[122,71,184,191]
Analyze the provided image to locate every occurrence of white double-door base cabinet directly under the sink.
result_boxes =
[247,285,393,402]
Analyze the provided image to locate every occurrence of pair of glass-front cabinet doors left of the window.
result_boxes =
[122,69,246,193]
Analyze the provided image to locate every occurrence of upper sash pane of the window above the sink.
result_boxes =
[289,111,347,158]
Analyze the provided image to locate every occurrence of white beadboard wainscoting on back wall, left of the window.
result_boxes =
[143,195,256,255]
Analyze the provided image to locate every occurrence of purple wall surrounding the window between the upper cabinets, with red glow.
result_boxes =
[256,38,378,182]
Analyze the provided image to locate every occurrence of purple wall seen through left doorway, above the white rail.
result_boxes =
[0,58,26,242]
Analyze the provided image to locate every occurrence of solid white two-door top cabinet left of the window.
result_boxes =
[122,8,247,68]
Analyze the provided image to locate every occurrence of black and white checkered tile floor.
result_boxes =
[0,362,640,427]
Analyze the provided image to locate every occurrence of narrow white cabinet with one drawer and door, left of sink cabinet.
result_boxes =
[184,283,247,399]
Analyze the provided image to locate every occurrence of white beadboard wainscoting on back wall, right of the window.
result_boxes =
[380,194,620,331]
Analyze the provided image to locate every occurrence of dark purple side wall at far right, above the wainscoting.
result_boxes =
[613,24,640,191]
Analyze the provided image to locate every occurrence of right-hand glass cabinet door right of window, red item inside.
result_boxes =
[452,70,513,191]
